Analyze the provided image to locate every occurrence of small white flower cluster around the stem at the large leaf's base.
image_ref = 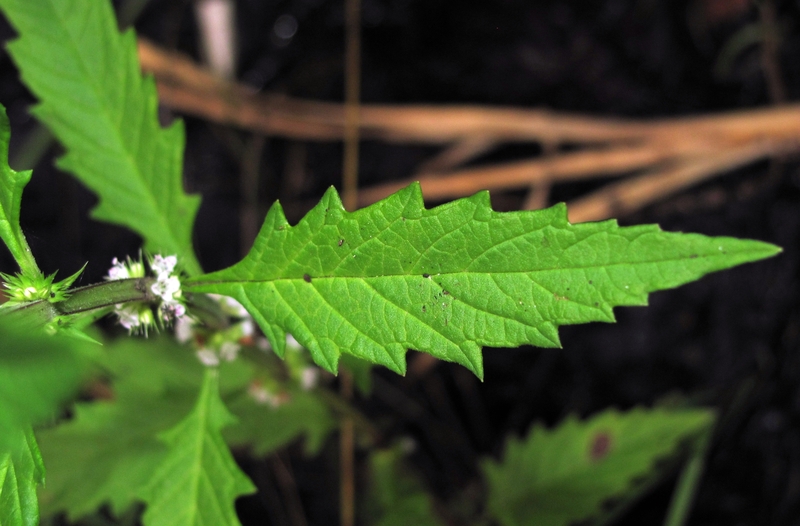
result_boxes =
[106,254,186,336]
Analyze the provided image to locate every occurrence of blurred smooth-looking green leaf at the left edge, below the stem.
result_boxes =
[0,323,85,451]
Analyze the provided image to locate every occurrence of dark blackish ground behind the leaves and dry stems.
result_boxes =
[0,0,800,526]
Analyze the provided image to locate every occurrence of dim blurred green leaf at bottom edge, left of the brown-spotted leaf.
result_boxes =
[368,446,444,526]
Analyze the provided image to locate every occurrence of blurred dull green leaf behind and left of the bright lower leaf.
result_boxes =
[39,338,250,520]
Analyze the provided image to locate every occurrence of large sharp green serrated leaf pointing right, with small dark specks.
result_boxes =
[185,184,780,377]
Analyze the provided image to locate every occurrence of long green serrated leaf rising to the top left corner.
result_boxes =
[0,0,200,274]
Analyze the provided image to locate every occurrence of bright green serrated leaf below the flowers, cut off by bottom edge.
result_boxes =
[142,369,255,526]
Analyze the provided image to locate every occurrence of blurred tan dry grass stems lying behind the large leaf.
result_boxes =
[139,40,800,221]
